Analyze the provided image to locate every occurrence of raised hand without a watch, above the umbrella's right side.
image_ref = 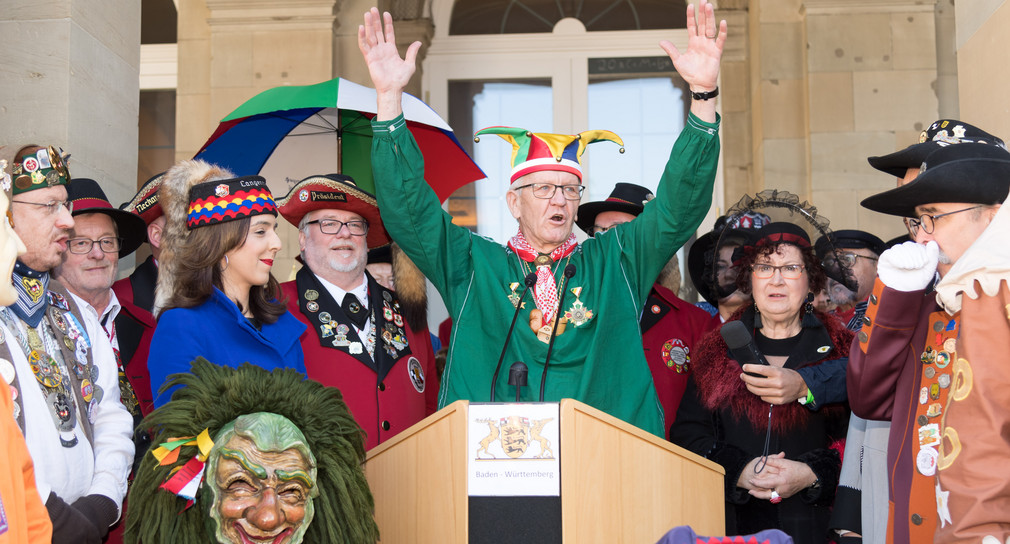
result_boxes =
[358,8,421,120]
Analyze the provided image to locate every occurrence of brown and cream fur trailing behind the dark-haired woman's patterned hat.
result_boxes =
[153,159,235,317]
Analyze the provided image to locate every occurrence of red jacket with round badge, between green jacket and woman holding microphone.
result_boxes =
[639,284,712,440]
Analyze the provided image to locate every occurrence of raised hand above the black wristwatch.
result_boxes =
[660,0,726,92]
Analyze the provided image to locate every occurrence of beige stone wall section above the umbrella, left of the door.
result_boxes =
[176,0,339,158]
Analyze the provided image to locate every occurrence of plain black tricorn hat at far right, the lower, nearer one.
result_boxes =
[861,144,1010,217]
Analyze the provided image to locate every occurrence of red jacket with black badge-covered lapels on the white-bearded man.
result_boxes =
[281,266,438,449]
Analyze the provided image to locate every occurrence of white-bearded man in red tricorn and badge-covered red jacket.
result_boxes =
[277,174,438,449]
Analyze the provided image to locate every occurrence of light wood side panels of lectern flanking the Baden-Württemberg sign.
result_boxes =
[365,399,725,544]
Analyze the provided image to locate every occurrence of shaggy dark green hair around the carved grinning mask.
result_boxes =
[124,357,379,544]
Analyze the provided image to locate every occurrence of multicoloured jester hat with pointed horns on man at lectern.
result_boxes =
[474,126,624,184]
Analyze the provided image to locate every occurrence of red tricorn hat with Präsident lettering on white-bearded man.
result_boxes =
[277,174,390,249]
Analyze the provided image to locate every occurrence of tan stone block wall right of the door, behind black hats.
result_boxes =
[739,0,938,239]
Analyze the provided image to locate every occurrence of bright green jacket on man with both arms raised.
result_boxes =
[372,115,719,436]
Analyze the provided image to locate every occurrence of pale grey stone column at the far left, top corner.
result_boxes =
[0,0,140,207]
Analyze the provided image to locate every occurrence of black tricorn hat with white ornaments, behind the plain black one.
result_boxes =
[867,119,1006,178]
